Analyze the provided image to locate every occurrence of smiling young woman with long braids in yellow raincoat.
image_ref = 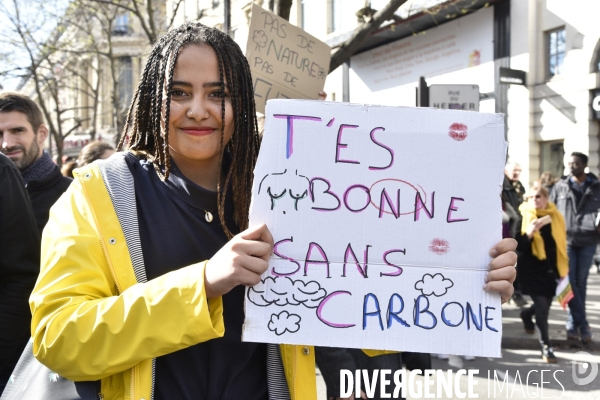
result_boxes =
[30,23,516,400]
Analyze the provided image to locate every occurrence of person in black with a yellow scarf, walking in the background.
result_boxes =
[517,187,569,363]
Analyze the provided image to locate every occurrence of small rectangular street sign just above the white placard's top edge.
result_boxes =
[429,85,479,111]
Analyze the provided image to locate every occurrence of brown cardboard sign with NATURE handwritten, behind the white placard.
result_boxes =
[246,4,331,114]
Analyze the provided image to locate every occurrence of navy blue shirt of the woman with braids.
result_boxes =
[127,155,268,400]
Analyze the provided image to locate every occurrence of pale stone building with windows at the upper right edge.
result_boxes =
[507,0,600,182]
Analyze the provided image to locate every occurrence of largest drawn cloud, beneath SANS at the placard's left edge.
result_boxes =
[248,276,327,308]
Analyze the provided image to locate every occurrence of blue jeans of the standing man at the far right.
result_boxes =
[566,246,596,330]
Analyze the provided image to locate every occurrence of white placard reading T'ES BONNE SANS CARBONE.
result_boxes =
[243,100,507,357]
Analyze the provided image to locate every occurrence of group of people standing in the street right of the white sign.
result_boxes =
[502,152,600,363]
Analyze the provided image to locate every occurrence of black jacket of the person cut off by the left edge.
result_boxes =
[0,154,40,393]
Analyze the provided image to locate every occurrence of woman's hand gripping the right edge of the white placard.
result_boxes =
[483,239,517,304]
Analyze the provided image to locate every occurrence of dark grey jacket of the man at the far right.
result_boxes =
[550,174,600,247]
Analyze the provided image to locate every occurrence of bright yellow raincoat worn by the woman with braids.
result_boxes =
[30,164,316,400]
